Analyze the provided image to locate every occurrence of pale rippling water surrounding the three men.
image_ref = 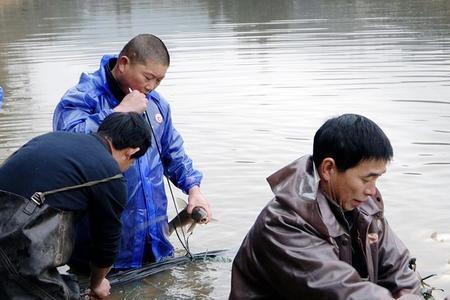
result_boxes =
[0,0,450,299]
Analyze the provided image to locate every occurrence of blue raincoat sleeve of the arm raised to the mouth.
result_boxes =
[53,75,113,133]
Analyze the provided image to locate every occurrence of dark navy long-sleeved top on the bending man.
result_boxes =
[0,132,127,267]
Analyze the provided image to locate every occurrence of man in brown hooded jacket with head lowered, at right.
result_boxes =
[230,114,422,300]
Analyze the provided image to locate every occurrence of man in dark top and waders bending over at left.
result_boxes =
[0,113,151,299]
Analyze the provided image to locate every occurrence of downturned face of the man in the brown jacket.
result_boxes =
[327,160,387,211]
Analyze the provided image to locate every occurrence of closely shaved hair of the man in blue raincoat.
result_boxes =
[119,34,170,66]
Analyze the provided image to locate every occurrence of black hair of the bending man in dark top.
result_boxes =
[98,112,152,158]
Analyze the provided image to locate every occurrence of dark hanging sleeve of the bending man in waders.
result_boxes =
[89,178,127,268]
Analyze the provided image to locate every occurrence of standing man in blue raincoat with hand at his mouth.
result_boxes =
[53,34,211,269]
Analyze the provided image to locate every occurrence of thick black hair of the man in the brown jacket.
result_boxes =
[313,114,394,172]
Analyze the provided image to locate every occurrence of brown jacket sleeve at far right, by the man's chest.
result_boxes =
[378,219,420,296]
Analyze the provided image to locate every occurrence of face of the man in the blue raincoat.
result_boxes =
[120,60,168,94]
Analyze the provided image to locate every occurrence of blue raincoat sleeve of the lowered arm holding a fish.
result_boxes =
[157,103,203,194]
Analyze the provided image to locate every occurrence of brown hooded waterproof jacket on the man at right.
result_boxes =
[230,156,422,300]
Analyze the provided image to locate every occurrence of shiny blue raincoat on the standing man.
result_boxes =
[53,55,202,269]
